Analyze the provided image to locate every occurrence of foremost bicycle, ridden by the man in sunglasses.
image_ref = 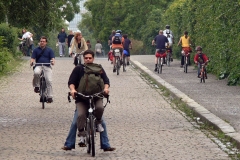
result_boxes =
[68,92,110,157]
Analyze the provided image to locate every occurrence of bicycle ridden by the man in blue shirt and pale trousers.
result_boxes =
[35,63,51,109]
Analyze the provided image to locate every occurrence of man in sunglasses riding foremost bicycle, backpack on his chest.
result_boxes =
[68,50,109,144]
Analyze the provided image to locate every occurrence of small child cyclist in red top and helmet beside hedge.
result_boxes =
[194,46,209,79]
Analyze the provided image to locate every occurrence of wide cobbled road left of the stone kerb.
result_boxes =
[0,58,229,160]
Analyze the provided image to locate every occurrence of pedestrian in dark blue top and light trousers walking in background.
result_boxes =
[57,28,68,57]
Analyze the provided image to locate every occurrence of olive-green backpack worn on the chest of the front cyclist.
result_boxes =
[77,63,104,95]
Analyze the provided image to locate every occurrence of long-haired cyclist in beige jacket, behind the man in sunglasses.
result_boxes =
[70,32,88,66]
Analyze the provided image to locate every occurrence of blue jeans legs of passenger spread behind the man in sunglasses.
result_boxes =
[64,110,110,149]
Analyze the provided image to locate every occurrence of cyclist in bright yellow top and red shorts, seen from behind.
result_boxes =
[177,31,192,68]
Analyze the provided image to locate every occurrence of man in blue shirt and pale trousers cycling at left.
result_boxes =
[30,36,55,103]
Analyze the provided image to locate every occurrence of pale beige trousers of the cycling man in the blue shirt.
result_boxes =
[33,66,53,98]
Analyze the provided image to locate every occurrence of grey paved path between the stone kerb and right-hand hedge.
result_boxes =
[131,55,240,132]
